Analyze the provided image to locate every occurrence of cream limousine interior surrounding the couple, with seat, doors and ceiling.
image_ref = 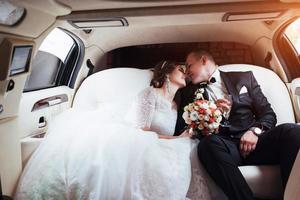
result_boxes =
[0,0,300,200]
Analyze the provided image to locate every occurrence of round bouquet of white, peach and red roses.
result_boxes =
[182,88,222,136]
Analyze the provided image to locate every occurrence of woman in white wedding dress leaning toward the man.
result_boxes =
[15,61,220,200]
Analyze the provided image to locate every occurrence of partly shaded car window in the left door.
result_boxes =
[24,28,76,92]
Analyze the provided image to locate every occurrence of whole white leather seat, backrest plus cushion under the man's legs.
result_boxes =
[73,64,295,198]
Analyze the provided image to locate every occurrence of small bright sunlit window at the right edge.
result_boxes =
[284,18,300,55]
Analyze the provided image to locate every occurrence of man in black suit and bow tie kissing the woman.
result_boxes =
[175,49,300,200]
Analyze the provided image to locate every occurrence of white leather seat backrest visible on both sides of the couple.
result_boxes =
[73,64,295,124]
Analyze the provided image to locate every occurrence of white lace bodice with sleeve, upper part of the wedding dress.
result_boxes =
[127,87,177,135]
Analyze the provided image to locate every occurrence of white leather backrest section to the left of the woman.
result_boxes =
[73,68,153,110]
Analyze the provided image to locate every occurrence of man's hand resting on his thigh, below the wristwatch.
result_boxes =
[240,131,258,158]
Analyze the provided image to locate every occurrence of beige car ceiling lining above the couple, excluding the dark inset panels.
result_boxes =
[0,0,300,52]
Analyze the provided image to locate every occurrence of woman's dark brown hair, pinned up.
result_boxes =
[150,60,180,88]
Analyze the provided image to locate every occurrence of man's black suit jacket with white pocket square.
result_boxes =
[174,71,277,138]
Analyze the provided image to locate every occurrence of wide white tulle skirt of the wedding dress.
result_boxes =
[15,109,196,200]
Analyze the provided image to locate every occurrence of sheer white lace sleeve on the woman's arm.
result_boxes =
[126,87,155,129]
